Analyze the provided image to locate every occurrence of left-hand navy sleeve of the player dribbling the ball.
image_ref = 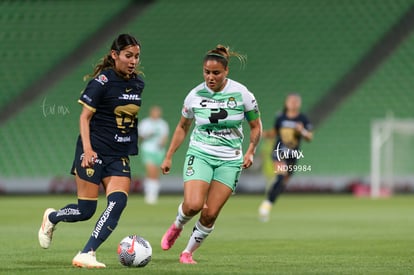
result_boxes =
[78,74,108,112]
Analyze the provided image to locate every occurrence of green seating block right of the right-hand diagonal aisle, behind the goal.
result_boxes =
[304,31,414,176]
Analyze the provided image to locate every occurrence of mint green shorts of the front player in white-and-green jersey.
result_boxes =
[183,154,242,191]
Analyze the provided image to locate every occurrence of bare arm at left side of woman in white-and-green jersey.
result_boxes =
[161,116,193,175]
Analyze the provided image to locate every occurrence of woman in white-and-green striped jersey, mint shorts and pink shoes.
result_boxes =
[161,45,262,264]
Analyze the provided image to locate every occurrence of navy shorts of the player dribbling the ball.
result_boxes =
[70,143,131,185]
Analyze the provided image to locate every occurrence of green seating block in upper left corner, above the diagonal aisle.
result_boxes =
[0,0,129,110]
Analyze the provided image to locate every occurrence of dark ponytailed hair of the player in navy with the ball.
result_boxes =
[83,34,141,81]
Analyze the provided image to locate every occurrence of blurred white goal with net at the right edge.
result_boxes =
[371,117,414,198]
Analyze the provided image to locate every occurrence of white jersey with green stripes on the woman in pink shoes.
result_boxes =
[182,79,259,160]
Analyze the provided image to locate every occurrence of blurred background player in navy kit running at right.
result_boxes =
[259,93,313,221]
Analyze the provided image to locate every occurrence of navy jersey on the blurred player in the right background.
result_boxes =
[274,113,312,150]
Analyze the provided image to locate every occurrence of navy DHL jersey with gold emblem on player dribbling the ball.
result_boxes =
[79,69,144,156]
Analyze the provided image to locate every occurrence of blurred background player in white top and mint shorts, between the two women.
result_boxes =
[138,106,169,204]
